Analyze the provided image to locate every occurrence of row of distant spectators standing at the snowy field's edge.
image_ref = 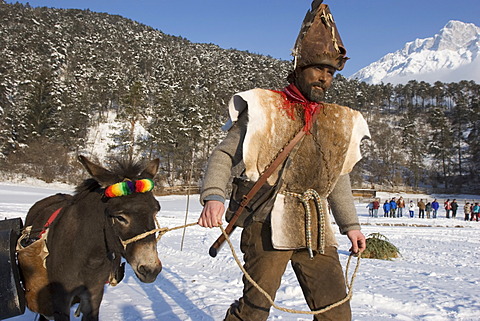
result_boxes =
[367,196,480,222]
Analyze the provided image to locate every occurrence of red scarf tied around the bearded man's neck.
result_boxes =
[275,83,323,132]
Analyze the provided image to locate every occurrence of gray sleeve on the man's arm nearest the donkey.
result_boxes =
[200,112,248,205]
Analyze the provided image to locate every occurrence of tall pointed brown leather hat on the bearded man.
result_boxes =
[292,0,348,70]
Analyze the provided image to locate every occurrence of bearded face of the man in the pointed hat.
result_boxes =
[295,65,335,103]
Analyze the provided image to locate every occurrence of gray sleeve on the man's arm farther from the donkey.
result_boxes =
[328,174,360,234]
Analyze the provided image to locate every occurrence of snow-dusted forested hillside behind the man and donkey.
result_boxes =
[0,0,480,192]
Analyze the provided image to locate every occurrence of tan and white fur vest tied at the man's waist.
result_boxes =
[229,89,369,250]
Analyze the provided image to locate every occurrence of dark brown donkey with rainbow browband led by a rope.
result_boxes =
[18,156,162,321]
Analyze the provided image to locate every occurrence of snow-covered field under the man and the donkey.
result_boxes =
[0,182,480,321]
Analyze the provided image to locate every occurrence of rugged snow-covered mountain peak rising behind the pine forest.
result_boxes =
[349,20,480,84]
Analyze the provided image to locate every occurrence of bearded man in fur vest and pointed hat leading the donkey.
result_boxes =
[198,1,369,321]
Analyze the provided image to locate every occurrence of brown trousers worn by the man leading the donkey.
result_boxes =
[225,222,351,321]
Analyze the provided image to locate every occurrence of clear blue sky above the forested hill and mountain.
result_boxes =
[7,0,480,76]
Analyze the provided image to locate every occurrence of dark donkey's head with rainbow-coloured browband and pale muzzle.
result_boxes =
[79,156,162,283]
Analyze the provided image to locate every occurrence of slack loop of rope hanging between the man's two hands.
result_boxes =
[220,225,361,315]
